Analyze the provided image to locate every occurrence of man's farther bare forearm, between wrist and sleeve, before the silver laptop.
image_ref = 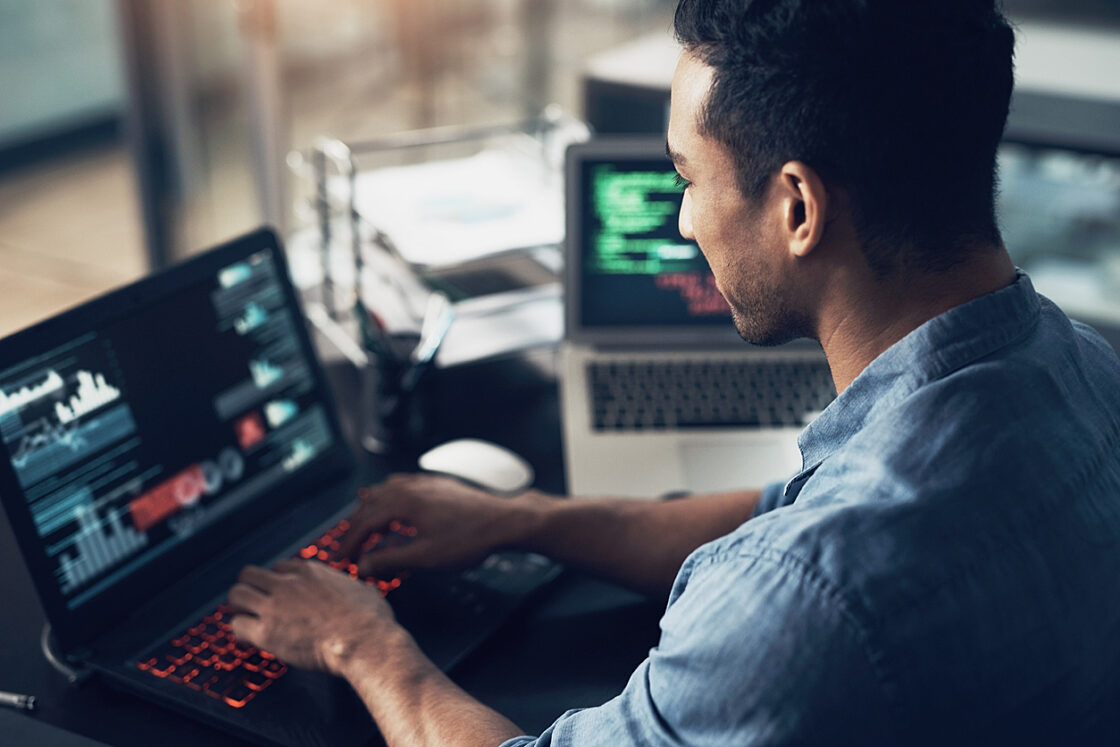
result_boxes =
[514,491,762,594]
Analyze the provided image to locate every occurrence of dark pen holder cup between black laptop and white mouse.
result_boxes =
[360,356,427,455]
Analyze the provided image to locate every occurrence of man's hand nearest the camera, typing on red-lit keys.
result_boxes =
[230,560,403,674]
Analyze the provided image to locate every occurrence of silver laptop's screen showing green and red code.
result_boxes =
[564,136,766,346]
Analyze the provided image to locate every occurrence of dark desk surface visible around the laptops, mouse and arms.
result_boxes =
[0,353,663,747]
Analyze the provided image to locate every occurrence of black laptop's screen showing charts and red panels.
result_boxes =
[0,232,349,645]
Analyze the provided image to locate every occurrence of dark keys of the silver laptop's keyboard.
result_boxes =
[587,358,836,430]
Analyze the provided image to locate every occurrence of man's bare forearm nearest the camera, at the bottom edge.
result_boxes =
[330,628,524,747]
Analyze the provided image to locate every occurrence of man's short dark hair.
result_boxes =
[674,0,1015,273]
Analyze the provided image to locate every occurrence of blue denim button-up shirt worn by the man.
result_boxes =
[505,274,1120,747]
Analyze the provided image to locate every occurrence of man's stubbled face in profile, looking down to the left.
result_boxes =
[669,53,808,345]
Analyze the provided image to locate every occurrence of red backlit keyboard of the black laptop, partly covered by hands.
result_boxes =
[137,521,416,708]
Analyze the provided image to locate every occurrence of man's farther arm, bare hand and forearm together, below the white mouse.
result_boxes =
[339,475,762,596]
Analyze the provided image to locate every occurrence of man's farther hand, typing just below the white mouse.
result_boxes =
[339,475,529,576]
